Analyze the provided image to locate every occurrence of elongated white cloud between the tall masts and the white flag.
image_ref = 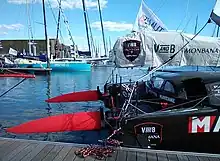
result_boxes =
[91,21,133,31]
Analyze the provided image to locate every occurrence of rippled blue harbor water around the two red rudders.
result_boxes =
[0,67,147,143]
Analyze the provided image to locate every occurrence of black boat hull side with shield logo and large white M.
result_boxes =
[122,110,220,153]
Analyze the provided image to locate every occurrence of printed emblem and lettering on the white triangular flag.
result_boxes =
[138,15,165,31]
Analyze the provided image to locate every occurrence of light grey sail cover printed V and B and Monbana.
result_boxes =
[113,31,220,67]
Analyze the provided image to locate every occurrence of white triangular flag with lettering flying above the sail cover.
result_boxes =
[133,0,167,32]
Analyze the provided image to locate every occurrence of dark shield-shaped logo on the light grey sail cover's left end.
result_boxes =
[123,40,141,62]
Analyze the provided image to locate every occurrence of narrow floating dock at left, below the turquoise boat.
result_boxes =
[0,68,52,75]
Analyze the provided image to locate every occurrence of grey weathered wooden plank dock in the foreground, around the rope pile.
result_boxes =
[0,137,220,161]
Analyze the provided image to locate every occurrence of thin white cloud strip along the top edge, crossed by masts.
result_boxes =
[8,0,108,9]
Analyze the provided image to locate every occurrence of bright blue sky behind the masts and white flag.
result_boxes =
[0,0,215,52]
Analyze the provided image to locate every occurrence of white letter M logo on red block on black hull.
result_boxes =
[188,116,220,133]
